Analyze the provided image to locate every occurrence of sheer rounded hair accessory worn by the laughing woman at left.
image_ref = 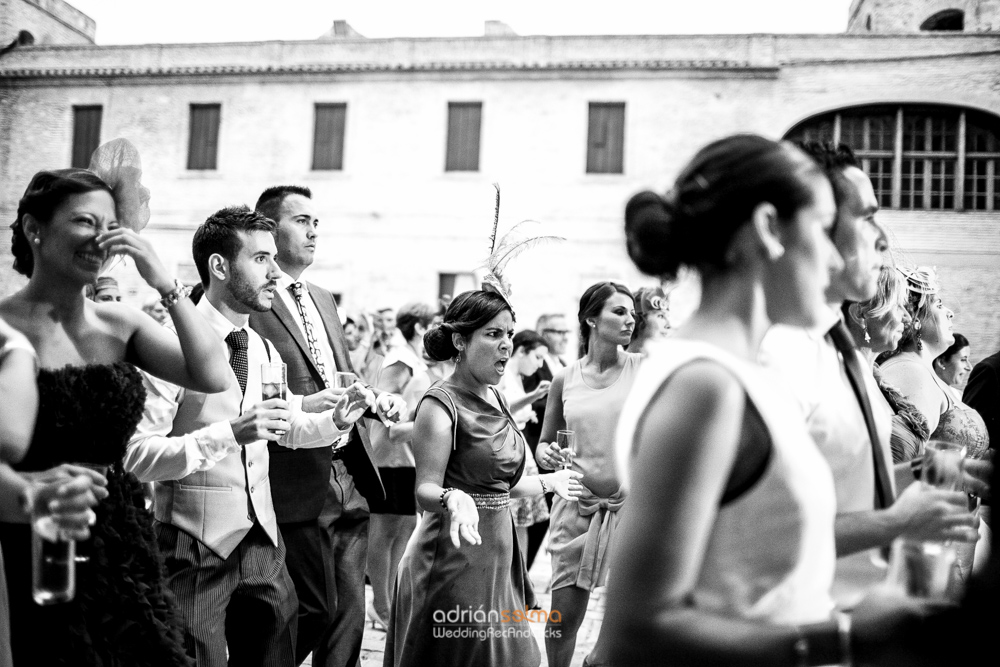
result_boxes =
[89,138,149,233]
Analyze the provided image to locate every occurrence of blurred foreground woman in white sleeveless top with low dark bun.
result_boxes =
[585,135,944,666]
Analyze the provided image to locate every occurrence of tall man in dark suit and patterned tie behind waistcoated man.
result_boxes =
[250,186,402,667]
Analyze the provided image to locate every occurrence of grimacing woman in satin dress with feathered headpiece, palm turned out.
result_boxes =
[385,291,581,667]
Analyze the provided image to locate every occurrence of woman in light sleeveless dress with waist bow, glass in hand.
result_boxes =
[535,281,641,667]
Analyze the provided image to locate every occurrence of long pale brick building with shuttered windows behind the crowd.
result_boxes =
[0,0,1000,359]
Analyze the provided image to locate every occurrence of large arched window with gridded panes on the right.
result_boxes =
[785,105,1000,211]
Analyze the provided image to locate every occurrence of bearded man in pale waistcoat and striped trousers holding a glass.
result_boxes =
[125,206,374,667]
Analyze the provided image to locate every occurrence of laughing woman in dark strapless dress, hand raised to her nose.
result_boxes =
[0,169,232,666]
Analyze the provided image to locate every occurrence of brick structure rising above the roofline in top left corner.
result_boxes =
[0,0,97,48]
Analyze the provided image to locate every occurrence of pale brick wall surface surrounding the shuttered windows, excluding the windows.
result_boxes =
[0,35,1000,366]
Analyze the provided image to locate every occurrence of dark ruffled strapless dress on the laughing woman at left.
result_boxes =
[0,362,193,667]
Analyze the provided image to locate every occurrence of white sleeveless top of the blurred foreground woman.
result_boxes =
[616,339,836,624]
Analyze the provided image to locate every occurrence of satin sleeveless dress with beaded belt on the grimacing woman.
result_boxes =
[385,379,541,667]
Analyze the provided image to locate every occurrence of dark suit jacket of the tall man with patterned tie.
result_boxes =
[250,283,385,523]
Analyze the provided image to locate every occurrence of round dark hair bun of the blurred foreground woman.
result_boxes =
[625,190,680,277]
